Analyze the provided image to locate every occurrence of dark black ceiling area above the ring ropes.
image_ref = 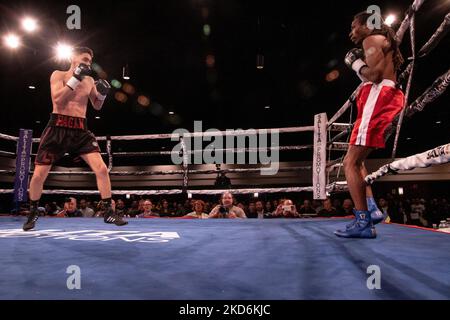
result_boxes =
[0,0,450,161]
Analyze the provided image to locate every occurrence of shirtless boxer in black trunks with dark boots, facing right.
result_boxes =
[23,47,127,231]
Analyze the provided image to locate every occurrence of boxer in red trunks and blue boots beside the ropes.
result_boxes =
[335,12,404,238]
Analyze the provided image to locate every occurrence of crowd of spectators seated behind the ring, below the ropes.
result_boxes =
[8,193,450,227]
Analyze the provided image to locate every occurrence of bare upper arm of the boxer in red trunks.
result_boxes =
[360,35,386,83]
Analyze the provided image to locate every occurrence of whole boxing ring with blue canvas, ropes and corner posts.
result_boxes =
[0,0,450,300]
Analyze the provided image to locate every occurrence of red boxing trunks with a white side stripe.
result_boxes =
[350,79,405,148]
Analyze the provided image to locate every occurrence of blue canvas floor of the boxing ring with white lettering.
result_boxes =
[0,218,450,300]
